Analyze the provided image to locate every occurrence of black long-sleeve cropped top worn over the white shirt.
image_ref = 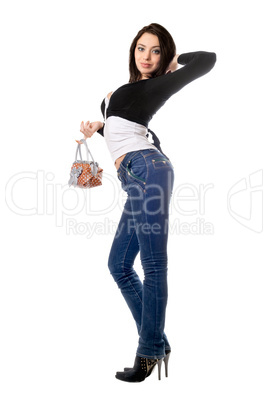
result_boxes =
[98,51,216,159]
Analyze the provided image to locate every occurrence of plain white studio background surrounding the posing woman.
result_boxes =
[0,0,268,402]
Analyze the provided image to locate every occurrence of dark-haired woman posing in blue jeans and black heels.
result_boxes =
[80,24,216,382]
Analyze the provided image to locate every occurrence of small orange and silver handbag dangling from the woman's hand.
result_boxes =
[68,139,103,188]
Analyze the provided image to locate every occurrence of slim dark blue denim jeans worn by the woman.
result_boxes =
[108,149,174,359]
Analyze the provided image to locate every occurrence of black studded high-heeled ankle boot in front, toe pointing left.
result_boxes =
[115,356,163,382]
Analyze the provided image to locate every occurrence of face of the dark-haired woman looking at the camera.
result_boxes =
[134,33,161,80]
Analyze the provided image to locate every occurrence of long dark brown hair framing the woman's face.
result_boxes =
[129,23,176,82]
